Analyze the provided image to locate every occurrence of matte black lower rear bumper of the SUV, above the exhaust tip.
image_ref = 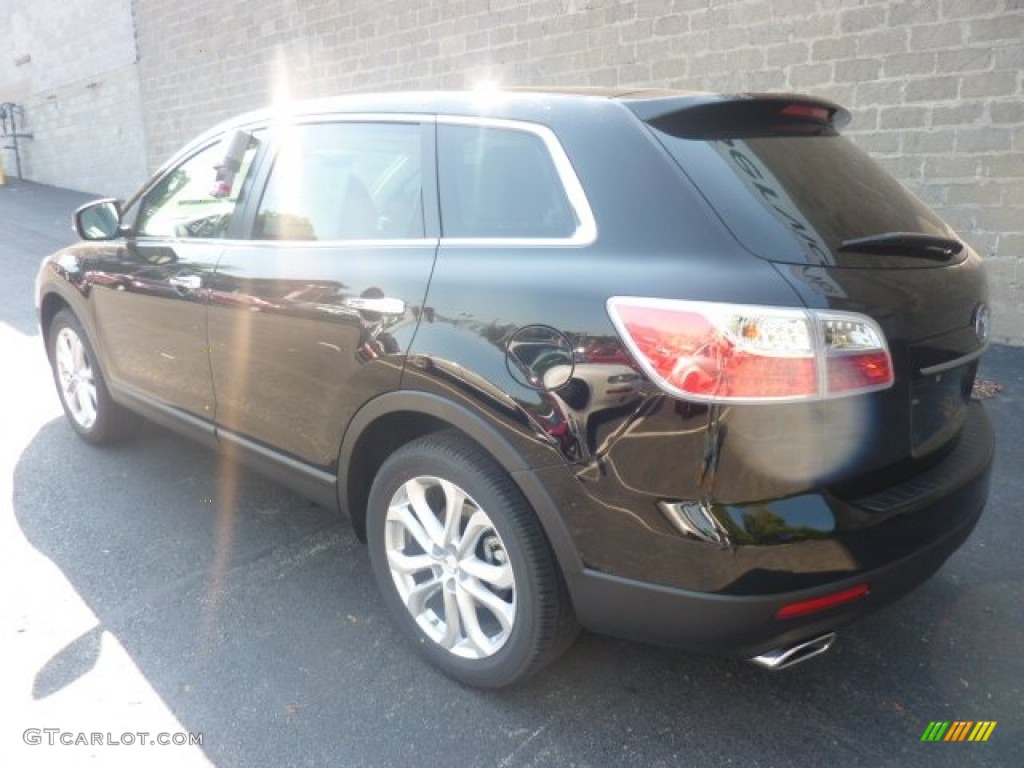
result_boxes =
[566,408,993,656]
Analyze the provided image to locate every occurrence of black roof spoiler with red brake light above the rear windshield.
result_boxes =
[623,93,850,139]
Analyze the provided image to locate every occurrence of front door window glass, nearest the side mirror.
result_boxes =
[135,131,263,238]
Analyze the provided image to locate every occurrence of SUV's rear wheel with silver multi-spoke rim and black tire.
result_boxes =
[367,431,578,688]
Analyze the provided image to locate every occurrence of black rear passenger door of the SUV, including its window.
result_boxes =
[209,116,438,470]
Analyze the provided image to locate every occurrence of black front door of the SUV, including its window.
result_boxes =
[94,132,258,422]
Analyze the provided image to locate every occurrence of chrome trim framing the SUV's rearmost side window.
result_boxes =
[437,115,597,248]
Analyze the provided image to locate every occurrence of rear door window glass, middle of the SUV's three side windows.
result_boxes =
[254,123,424,241]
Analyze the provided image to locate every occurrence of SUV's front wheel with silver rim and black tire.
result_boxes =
[47,309,140,444]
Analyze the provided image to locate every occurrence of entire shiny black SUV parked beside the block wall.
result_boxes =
[37,90,993,687]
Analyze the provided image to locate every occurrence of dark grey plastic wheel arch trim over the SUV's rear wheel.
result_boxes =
[338,390,583,584]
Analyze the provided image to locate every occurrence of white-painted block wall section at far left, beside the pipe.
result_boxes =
[0,0,146,197]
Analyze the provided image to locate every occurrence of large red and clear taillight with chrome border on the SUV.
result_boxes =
[607,296,893,402]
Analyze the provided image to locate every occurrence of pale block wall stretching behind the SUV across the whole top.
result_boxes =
[0,0,1024,344]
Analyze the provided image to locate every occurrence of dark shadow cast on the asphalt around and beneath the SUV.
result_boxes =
[14,376,1024,767]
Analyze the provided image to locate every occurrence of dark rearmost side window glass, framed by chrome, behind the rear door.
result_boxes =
[437,124,578,238]
